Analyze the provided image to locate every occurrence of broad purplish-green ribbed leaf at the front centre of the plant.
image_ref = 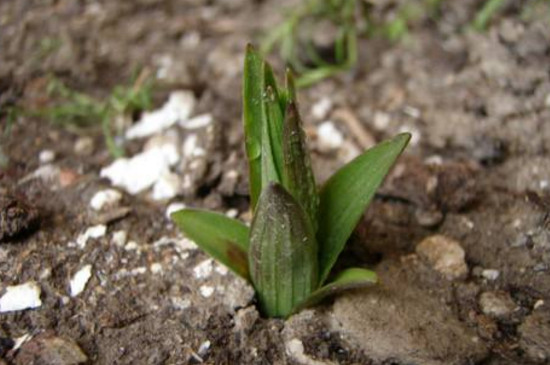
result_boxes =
[248,184,318,317]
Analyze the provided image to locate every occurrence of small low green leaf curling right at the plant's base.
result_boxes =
[292,268,378,313]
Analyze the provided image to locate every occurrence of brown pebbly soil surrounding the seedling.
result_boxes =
[0,0,550,364]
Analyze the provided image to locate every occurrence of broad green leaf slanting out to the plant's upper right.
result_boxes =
[317,133,411,283]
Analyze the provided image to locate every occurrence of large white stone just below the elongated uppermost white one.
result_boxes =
[100,143,179,194]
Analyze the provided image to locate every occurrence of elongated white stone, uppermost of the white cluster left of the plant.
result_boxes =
[126,91,195,139]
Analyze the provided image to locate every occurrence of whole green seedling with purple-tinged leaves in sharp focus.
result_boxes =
[172,46,410,317]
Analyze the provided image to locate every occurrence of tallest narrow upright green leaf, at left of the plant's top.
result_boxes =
[243,45,267,209]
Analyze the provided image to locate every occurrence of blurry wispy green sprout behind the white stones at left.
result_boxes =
[37,71,153,157]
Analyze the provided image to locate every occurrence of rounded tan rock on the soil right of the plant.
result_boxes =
[416,235,468,280]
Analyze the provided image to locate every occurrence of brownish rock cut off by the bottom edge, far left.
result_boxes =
[14,332,88,365]
